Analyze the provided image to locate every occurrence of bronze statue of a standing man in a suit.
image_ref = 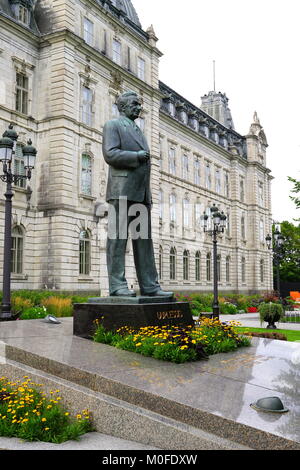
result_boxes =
[102,92,173,297]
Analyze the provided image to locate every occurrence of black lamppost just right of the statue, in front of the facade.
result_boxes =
[203,204,227,318]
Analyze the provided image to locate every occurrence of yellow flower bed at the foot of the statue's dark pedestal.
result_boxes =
[93,317,251,364]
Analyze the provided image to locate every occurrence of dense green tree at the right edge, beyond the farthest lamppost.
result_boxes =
[274,221,300,282]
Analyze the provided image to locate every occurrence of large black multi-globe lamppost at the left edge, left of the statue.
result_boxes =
[0,124,37,321]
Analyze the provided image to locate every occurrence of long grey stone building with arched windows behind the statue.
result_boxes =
[0,0,272,294]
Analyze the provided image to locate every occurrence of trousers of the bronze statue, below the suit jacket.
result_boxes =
[106,199,160,295]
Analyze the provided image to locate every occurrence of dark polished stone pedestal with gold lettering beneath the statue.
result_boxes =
[73,296,194,339]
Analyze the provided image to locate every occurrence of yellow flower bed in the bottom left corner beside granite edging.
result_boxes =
[0,376,92,444]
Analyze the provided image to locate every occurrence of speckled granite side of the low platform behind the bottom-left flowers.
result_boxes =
[0,359,250,450]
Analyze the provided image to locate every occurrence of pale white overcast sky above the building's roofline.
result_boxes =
[132,0,300,222]
